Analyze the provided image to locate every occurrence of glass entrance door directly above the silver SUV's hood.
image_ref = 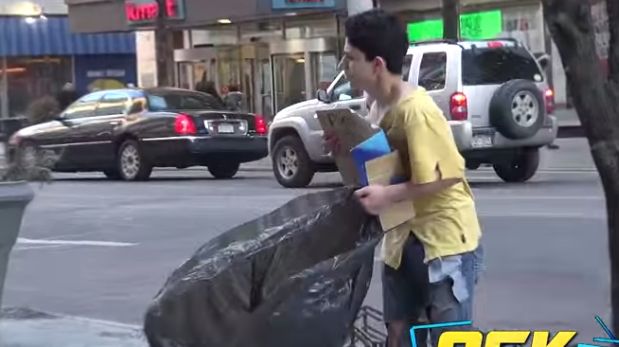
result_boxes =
[271,54,307,112]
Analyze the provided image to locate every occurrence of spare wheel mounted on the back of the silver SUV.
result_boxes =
[490,80,546,140]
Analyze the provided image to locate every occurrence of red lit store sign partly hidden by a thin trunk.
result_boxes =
[125,0,185,25]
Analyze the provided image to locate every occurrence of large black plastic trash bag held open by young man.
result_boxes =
[144,188,382,347]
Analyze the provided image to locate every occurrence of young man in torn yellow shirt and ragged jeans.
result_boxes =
[325,10,481,347]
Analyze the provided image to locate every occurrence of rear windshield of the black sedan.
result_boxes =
[147,91,225,111]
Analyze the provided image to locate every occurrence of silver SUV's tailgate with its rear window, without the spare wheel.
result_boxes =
[462,41,545,127]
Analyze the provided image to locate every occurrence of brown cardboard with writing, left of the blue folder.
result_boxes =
[316,108,377,186]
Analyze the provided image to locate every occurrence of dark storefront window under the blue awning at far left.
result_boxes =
[7,57,73,116]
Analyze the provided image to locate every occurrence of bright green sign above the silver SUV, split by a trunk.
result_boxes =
[407,10,503,42]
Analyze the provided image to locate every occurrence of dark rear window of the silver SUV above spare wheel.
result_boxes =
[462,47,543,85]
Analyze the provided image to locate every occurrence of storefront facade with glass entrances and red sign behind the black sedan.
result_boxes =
[67,0,375,117]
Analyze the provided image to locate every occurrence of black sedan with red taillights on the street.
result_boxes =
[9,88,268,181]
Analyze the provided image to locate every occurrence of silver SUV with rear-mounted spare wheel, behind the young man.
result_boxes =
[269,39,557,187]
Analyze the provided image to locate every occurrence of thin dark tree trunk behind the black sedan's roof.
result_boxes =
[155,0,174,87]
